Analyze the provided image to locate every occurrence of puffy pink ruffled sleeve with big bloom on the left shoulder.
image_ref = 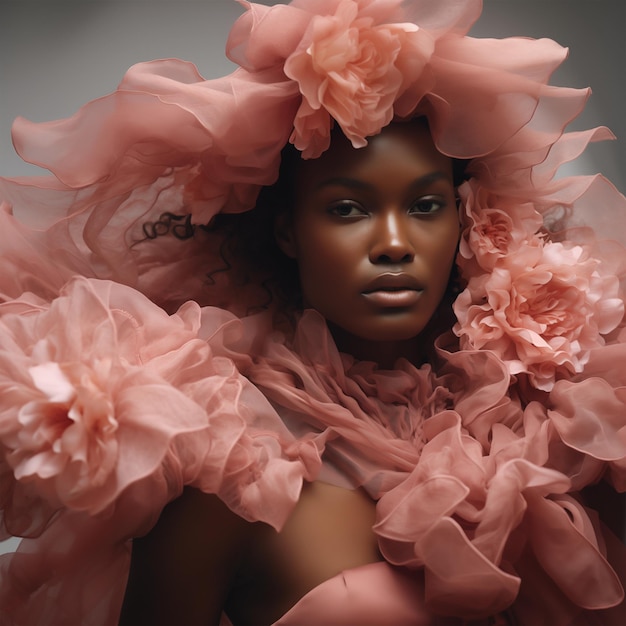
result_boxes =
[0,278,321,624]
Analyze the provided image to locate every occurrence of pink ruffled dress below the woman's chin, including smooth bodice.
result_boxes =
[0,288,626,624]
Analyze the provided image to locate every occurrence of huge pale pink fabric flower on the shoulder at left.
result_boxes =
[0,278,226,523]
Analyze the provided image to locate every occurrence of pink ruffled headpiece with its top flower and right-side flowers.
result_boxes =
[7,0,626,389]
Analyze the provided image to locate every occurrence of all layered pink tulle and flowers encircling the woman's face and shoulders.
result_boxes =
[0,0,626,624]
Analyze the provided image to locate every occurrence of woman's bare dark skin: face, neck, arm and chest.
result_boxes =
[121,122,623,626]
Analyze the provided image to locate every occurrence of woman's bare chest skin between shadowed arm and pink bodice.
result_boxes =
[227,482,381,624]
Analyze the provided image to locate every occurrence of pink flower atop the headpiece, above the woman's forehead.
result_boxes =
[285,0,434,158]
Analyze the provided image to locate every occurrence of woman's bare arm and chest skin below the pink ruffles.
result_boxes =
[120,483,380,625]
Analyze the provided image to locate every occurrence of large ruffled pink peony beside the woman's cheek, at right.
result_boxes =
[454,243,624,391]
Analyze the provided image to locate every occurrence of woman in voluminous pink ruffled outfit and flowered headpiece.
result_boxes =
[0,0,626,624]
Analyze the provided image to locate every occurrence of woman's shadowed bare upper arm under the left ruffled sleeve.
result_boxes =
[120,489,250,626]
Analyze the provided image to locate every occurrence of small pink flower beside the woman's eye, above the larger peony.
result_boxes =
[458,178,543,276]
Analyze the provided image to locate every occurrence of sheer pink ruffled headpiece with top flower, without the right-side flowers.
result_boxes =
[0,0,626,322]
